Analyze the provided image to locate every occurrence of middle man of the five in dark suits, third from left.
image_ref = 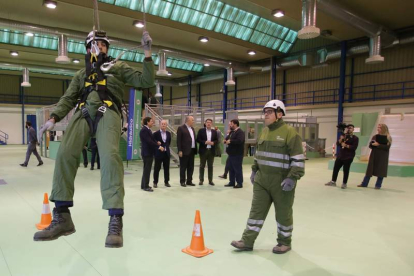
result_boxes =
[177,116,197,187]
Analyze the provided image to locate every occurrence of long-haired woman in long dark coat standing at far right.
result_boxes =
[358,124,392,189]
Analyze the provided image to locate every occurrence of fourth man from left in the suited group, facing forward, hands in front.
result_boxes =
[197,119,218,186]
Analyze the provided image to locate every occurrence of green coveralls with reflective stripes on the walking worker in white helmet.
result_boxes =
[242,119,305,247]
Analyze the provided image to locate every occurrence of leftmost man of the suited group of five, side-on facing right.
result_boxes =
[139,117,164,192]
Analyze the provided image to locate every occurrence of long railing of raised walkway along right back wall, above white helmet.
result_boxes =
[201,81,414,111]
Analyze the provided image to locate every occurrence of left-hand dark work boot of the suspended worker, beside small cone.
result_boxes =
[33,208,76,241]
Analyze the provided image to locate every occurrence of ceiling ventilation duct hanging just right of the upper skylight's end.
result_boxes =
[298,0,321,39]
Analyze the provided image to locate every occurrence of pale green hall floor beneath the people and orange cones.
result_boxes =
[0,145,414,276]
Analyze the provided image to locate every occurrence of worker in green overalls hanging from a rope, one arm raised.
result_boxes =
[34,31,155,247]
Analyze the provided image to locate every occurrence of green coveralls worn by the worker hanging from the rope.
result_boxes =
[50,60,155,210]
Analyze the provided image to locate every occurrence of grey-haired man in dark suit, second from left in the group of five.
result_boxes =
[154,120,171,188]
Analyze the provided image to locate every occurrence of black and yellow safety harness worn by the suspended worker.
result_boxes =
[78,51,121,136]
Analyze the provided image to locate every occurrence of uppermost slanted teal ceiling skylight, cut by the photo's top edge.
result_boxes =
[99,0,297,53]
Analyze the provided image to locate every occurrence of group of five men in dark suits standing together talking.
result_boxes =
[140,116,244,192]
